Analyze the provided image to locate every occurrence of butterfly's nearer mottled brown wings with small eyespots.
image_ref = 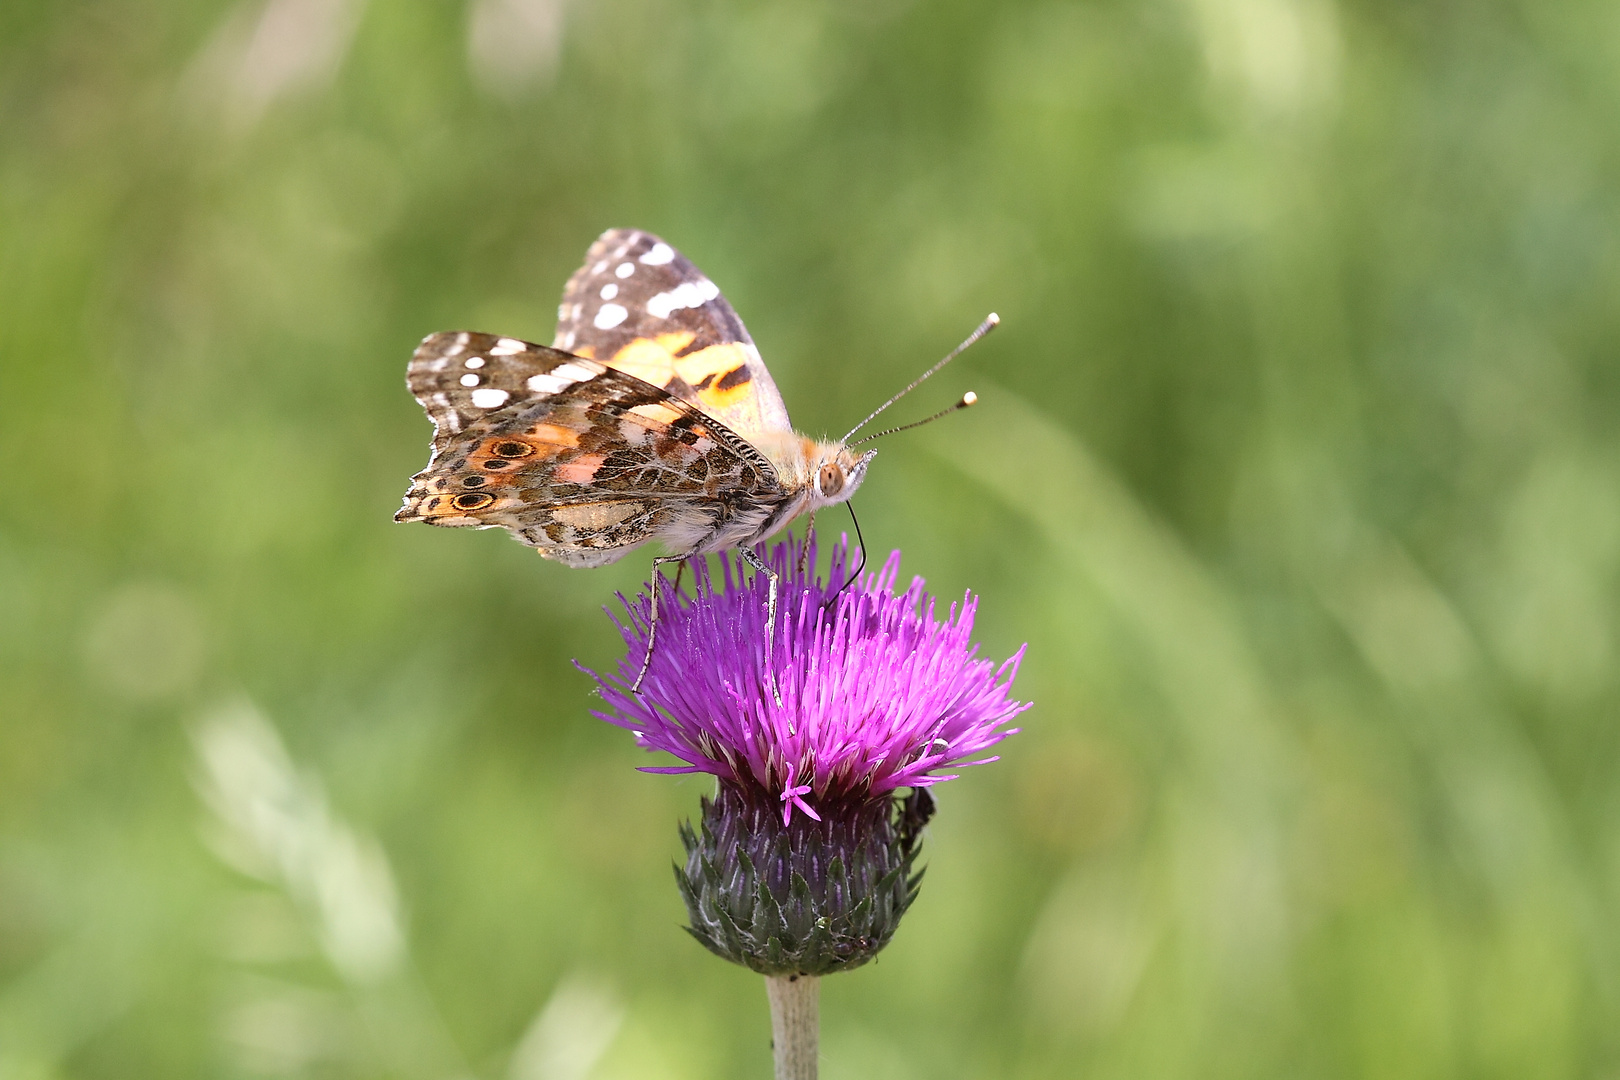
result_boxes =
[395,332,781,567]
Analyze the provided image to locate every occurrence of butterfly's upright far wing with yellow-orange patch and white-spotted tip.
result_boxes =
[552,228,792,439]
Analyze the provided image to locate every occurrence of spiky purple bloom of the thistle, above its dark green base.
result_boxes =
[588,541,1029,824]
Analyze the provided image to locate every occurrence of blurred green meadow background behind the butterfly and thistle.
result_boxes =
[0,0,1620,1080]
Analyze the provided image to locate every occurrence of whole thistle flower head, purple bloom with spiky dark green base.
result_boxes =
[579,541,1029,975]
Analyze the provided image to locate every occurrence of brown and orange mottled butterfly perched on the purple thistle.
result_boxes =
[394,228,995,690]
